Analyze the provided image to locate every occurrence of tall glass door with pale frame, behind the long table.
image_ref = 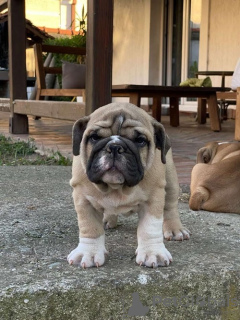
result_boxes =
[161,0,202,99]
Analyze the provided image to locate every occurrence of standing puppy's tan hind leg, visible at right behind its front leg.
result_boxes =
[163,149,190,241]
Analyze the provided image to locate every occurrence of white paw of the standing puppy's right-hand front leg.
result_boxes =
[136,243,172,268]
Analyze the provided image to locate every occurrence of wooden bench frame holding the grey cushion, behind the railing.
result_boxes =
[34,43,86,100]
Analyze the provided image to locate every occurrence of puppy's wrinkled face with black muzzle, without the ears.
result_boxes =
[85,114,151,187]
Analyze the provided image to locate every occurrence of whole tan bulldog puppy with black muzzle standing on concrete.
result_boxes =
[68,103,189,268]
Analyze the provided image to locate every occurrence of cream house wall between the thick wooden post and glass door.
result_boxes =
[113,0,150,84]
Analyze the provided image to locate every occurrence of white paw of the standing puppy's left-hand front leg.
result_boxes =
[67,235,108,268]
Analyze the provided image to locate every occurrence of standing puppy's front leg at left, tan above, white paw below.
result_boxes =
[67,200,107,268]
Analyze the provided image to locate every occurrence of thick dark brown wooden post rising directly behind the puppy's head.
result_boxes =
[86,0,113,114]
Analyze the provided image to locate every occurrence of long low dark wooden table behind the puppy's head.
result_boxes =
[112,84,229,131]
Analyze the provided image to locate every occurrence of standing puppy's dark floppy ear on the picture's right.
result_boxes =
[153,121,171,164]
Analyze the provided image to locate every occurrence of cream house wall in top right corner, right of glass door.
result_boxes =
[199,0,240,85]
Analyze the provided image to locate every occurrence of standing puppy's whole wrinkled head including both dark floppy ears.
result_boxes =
[73,104,169,187]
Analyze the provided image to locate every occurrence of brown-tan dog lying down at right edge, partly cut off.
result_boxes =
[189,142,240,213]
